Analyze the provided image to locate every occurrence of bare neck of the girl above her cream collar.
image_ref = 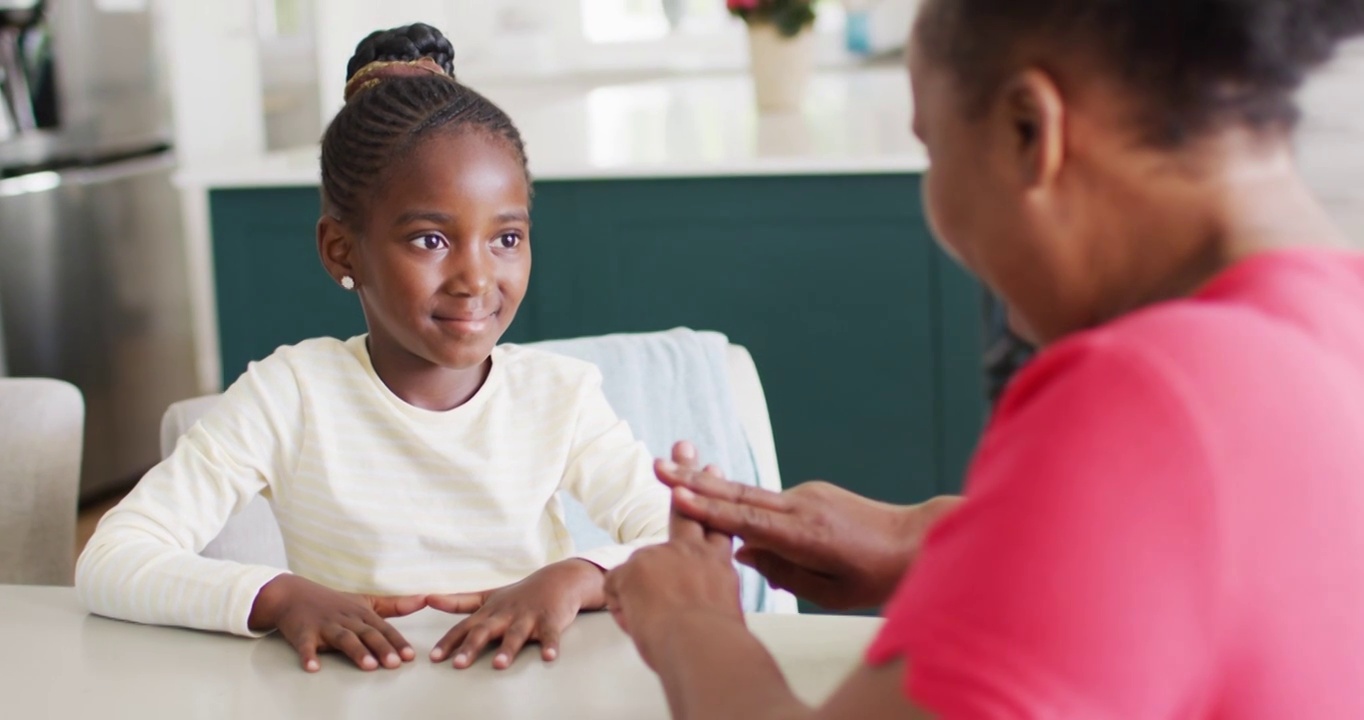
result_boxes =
[366,331,492,412]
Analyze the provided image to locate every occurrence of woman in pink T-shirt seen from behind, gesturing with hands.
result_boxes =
[607,0,1364,720]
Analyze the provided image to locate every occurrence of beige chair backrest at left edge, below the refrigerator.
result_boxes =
[0,378,85,585]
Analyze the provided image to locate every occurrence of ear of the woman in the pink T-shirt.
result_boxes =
[997,68,1067,190]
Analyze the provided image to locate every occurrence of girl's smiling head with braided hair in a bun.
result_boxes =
[318,25,531,368]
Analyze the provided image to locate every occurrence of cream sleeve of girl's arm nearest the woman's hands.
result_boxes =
[553,368,670,570]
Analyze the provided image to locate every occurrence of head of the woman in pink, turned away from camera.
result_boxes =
[911,0,1364,341]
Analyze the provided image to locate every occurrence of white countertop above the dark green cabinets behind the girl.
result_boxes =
[177,67,928,188]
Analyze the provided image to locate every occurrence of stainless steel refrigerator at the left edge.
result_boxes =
[0,0,196,500]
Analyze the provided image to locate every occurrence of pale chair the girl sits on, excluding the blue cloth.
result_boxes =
[161,338,797,614]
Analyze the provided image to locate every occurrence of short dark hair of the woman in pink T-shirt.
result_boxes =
[918,0,1364,146]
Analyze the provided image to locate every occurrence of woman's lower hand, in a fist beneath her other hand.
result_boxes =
[606,511,743,670]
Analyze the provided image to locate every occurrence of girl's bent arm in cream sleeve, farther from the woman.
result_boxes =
[76,356,301,635]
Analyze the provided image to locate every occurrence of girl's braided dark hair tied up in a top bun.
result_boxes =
[322,23,531,228]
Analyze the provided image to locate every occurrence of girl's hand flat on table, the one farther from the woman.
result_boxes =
[247,574,426,672]
